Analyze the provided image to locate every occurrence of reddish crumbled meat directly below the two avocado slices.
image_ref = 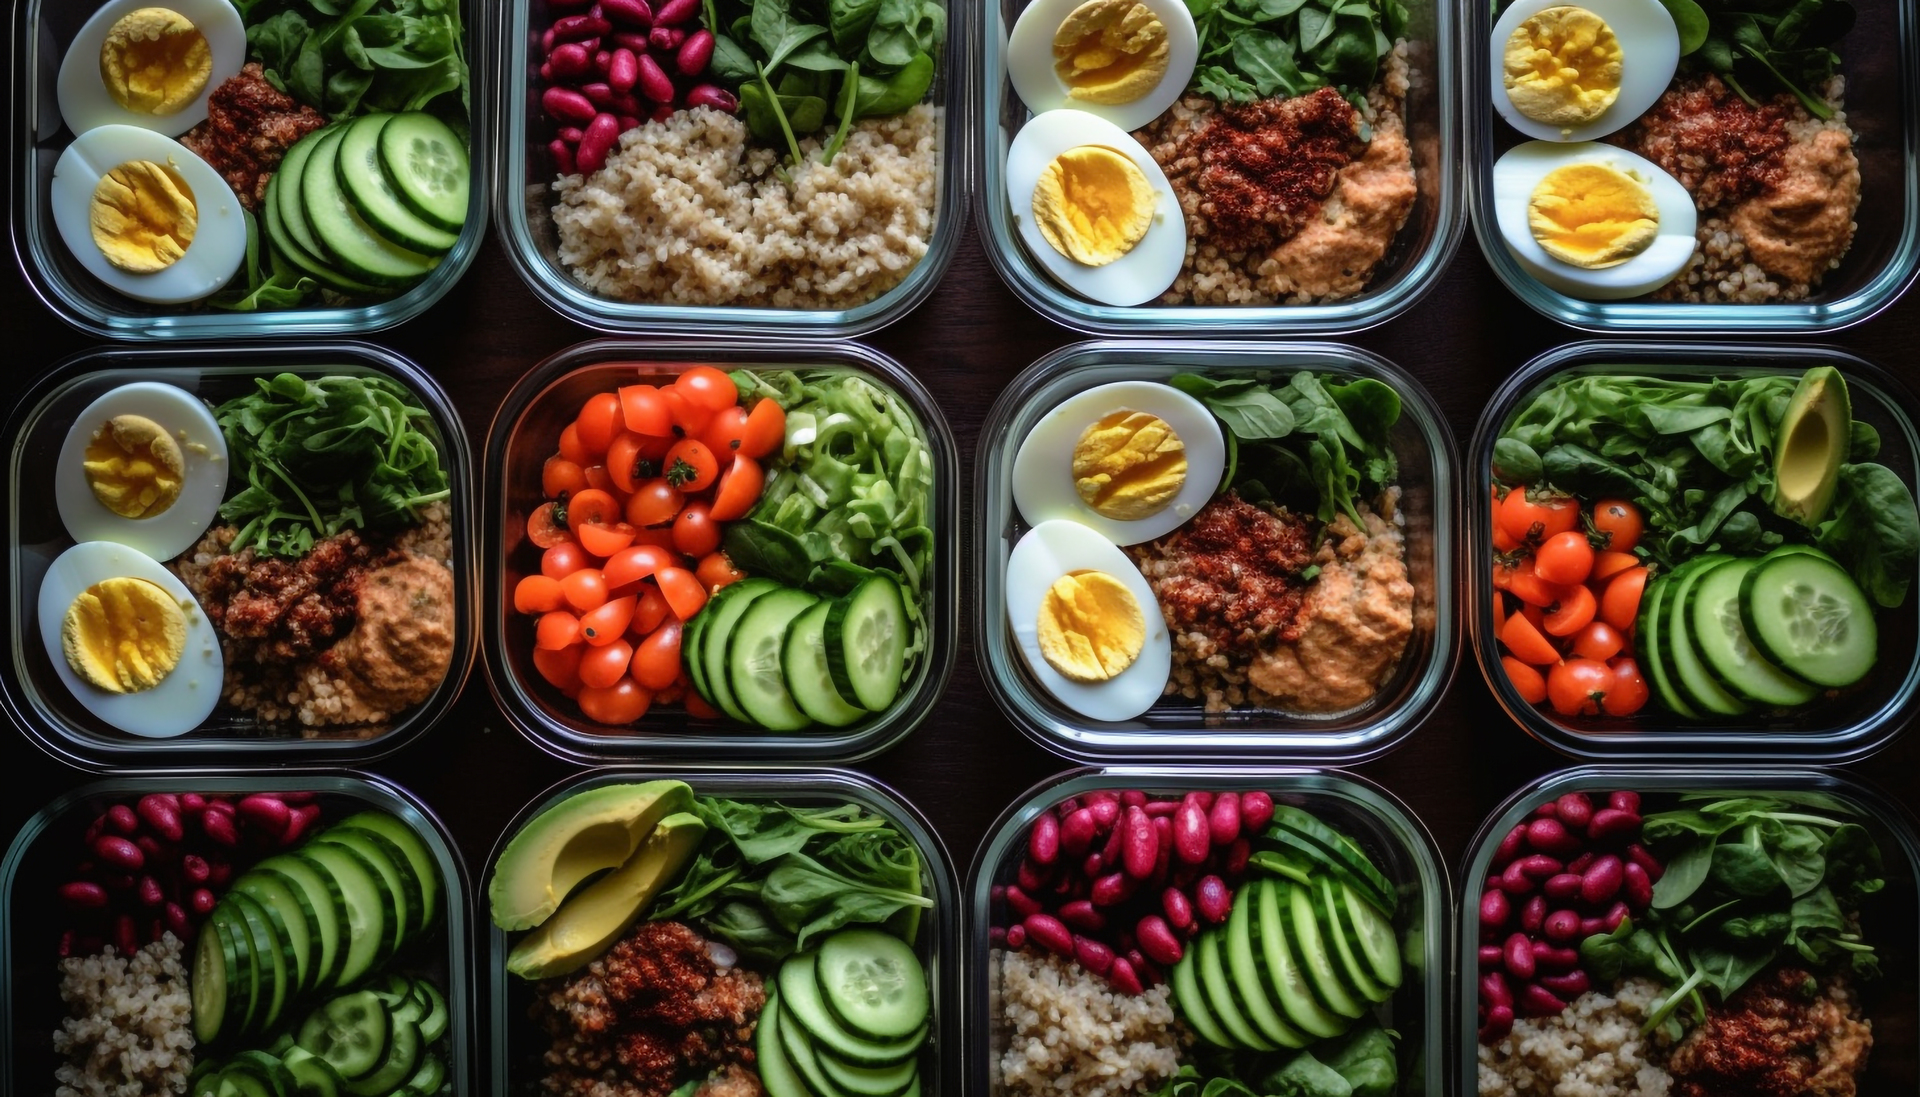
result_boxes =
[532,922,766,1097]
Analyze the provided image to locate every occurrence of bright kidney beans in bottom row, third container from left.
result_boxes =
[991,790,1273,993]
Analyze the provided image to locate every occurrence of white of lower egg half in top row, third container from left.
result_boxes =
[1006,110,1187,305]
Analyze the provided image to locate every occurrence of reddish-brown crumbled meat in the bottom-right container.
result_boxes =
[1667,968,1874,1097]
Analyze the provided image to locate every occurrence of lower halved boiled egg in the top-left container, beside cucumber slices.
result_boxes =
[50,125,246,305]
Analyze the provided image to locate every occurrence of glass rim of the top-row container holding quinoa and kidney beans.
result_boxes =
[490,0,973,340]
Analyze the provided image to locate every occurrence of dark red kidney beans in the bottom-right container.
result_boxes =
[1478,792,1663,1043]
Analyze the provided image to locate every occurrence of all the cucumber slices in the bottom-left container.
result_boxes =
[190,811,449,1097]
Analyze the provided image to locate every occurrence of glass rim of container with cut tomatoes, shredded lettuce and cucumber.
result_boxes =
[480,338,962,765]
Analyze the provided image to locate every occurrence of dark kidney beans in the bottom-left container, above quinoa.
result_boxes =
[58,792,321,957]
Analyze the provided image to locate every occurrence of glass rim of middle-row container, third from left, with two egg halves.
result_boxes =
[972,338,1459,767]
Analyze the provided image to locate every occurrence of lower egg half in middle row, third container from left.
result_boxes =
[1006,519,1173,720]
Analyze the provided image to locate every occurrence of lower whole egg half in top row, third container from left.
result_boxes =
[1006,110,1187,305]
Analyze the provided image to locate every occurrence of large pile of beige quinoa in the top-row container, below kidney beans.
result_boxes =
[553,104,941,309]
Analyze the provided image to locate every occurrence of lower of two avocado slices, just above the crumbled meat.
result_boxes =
[507,811,707,980]
